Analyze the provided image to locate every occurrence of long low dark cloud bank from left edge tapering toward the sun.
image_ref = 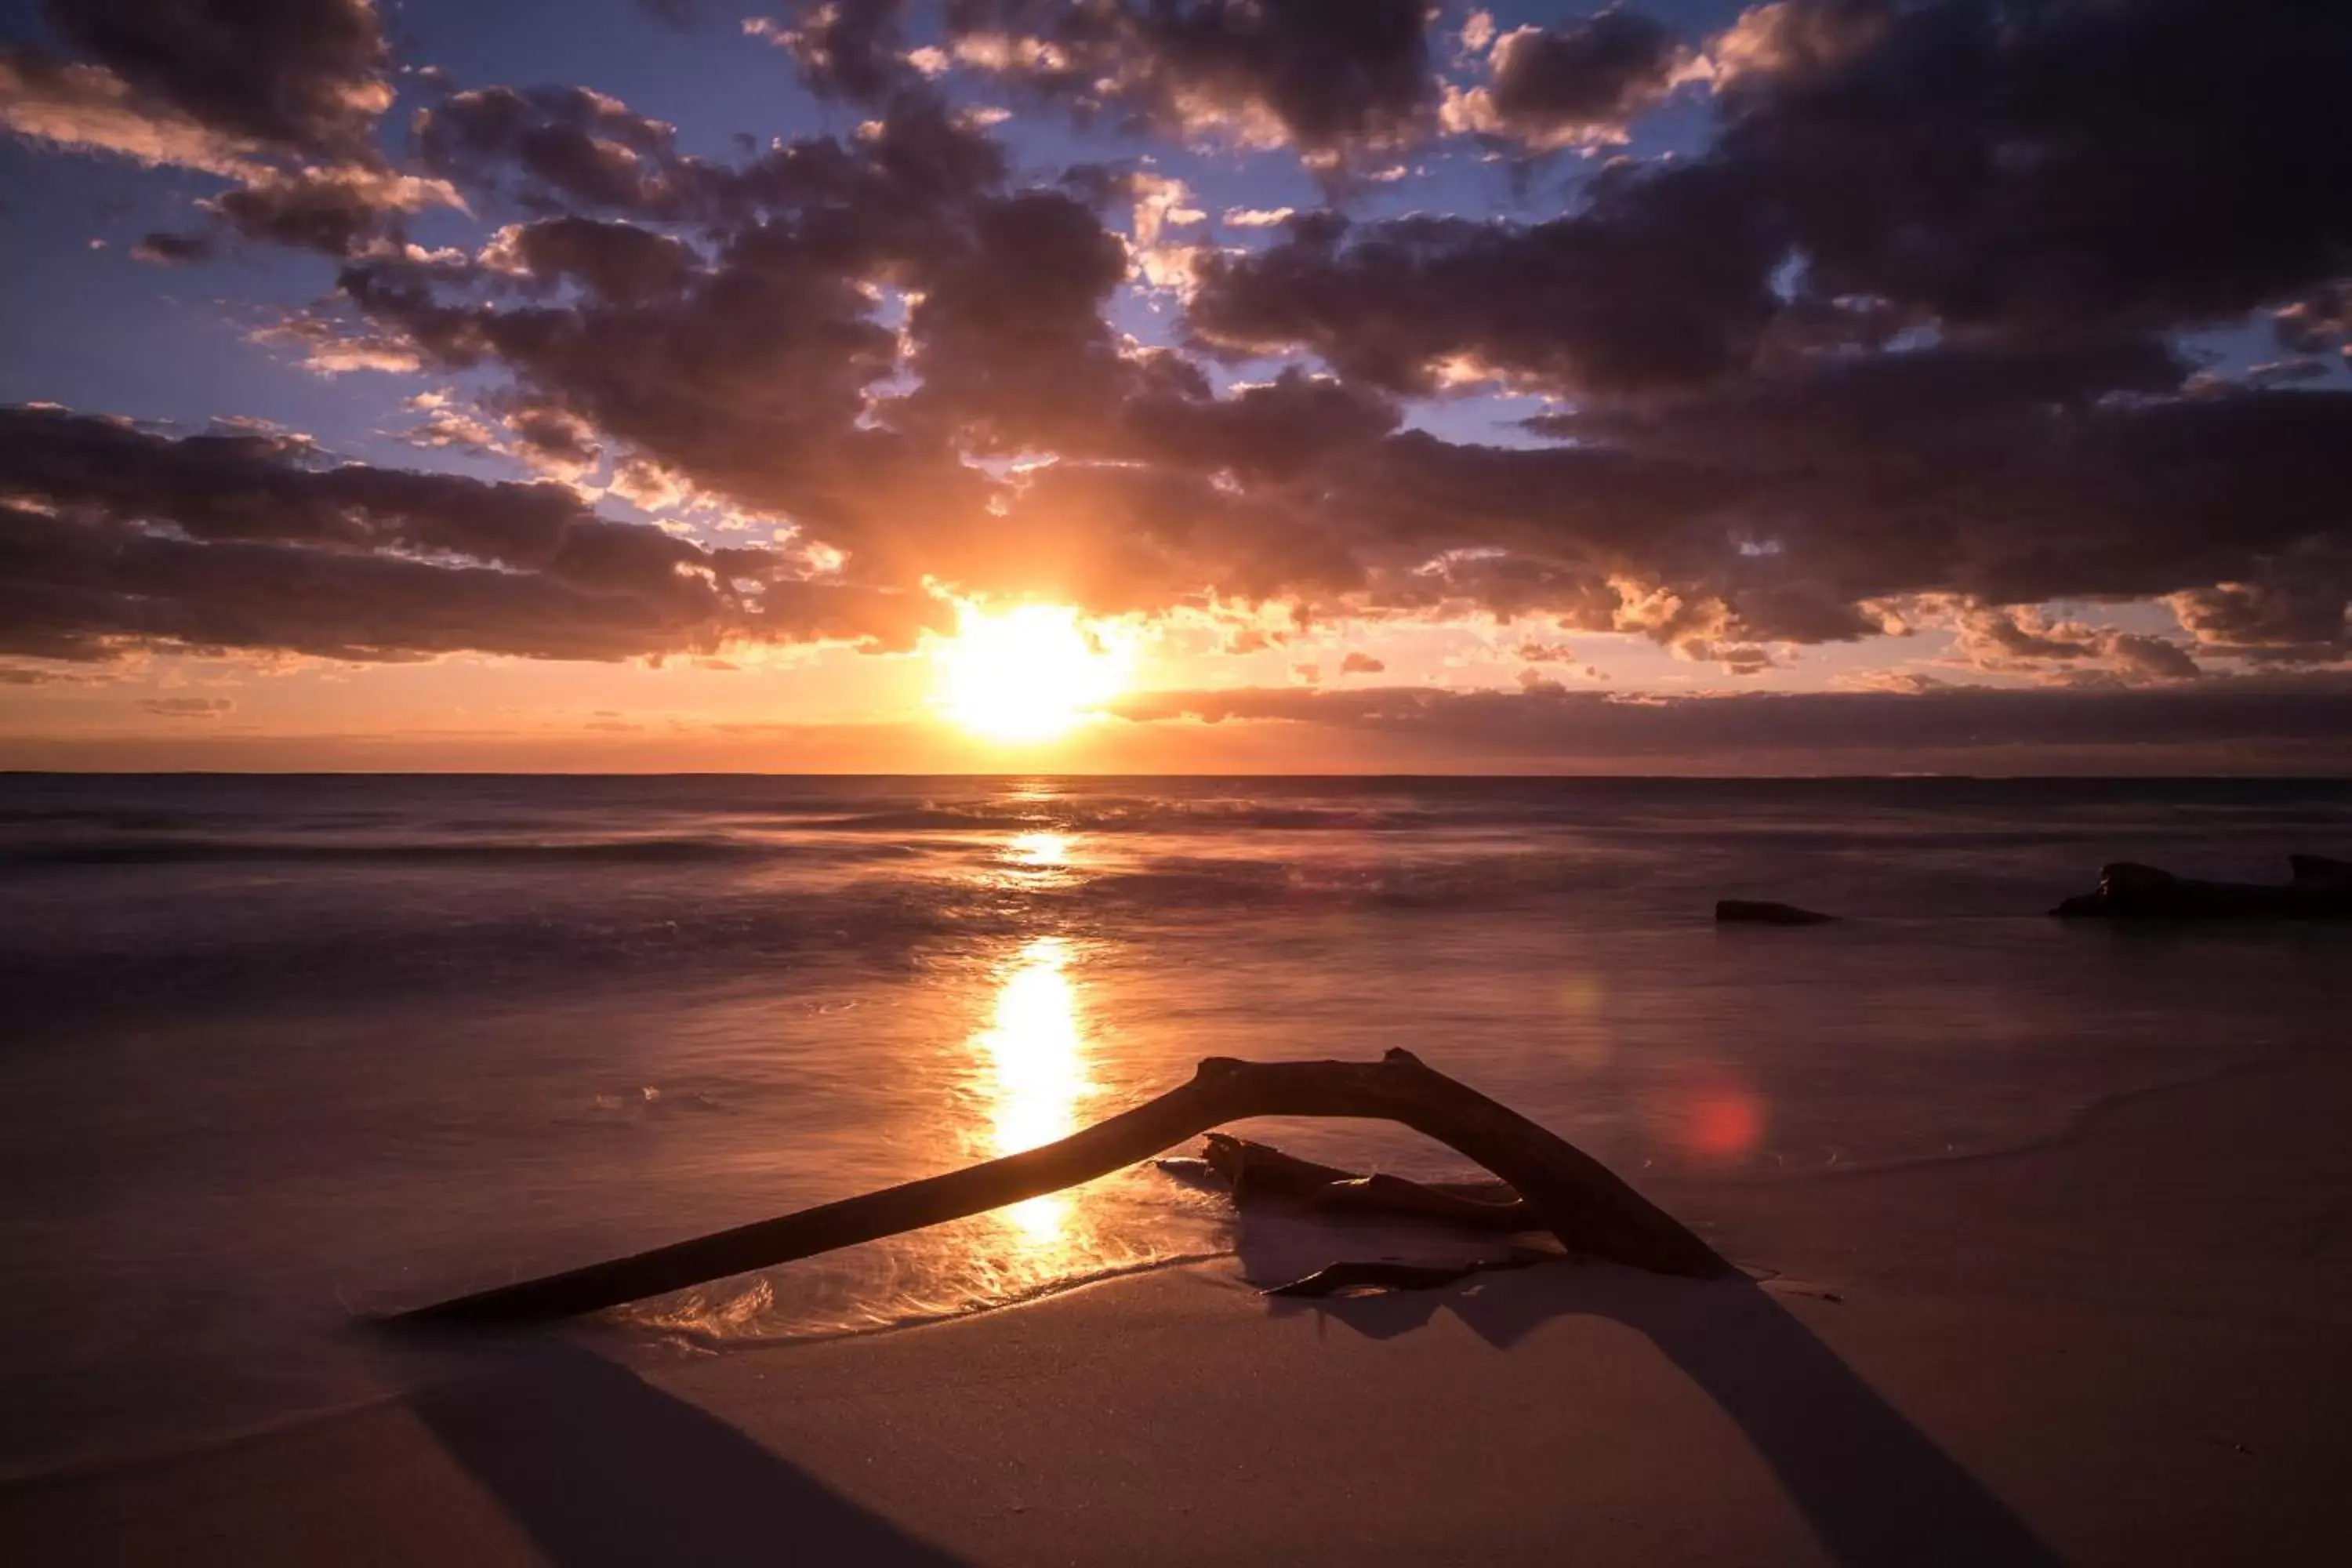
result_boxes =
[0,409,943,661]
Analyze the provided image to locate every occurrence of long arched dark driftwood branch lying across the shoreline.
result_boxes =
[390,1051,1729,1326]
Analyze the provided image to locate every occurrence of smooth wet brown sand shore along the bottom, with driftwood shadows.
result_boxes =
[0,1058,2352,1566]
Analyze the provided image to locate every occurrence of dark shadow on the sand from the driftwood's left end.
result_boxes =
[409,1340,962,1568]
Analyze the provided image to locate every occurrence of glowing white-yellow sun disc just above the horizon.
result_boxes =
[936,604,1127,743]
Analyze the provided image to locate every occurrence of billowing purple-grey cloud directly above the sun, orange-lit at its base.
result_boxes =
[341,89,1143,586]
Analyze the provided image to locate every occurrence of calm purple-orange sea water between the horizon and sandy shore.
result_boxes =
[0,776,2352,1474]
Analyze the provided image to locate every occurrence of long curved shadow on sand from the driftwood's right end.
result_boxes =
[1240,1220,2063,1568]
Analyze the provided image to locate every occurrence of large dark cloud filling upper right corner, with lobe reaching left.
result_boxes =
[1195,0,2352,376]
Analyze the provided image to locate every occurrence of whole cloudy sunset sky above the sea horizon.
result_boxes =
[0,0,2352,774]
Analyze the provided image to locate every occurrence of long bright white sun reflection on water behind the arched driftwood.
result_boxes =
[974,940,1091,1248]
